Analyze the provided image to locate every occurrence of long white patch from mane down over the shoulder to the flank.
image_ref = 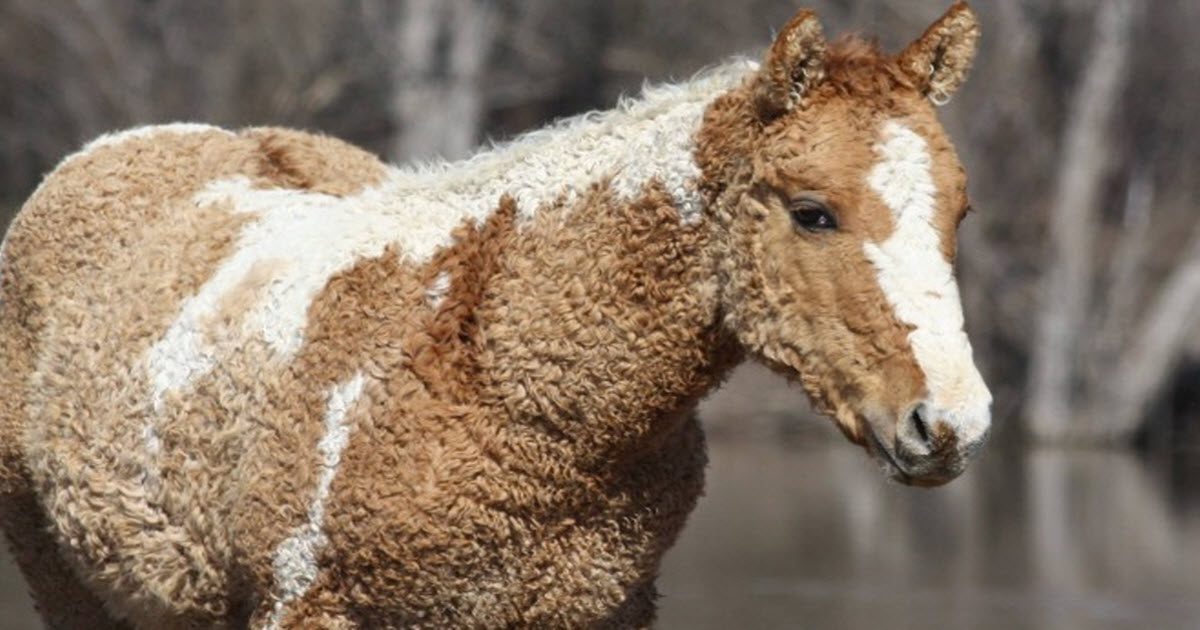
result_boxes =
[145,61,756,403]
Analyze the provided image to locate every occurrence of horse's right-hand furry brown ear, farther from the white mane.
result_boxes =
[899,1,979,106]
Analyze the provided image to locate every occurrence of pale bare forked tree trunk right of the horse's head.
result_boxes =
[1026,0,1200,443]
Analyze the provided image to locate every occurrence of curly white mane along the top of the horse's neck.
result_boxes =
[396,60,757,222]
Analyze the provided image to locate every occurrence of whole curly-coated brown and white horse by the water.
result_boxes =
[0,4,990,628]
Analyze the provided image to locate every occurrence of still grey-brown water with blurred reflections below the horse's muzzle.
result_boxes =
[659,439,1200,630]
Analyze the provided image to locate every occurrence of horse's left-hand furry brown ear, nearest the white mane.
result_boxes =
[755,8,826,120]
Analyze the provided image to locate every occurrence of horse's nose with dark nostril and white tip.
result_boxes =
[894,402,991,485]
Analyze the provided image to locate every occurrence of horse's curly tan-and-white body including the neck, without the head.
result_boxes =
[4,64,749,626]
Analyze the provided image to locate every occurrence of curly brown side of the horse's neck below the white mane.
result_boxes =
[476,187,738,457]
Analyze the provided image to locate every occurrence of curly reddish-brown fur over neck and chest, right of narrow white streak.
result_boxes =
[219,178,736,628]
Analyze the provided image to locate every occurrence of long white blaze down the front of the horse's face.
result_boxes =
[863,120,991,444]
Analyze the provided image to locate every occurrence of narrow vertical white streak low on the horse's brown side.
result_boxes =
[266,373,362,629]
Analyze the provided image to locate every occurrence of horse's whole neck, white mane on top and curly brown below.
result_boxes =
[458,65,758,457]
